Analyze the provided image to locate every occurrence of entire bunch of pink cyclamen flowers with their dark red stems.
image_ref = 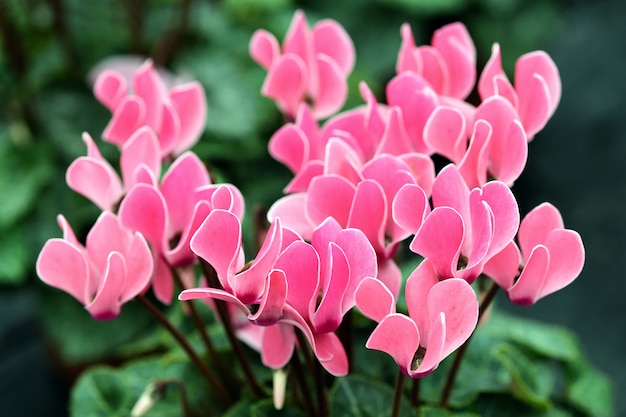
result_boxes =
[37,11,585,416]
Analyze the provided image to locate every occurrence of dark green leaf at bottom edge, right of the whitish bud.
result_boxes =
[330,375,415,417]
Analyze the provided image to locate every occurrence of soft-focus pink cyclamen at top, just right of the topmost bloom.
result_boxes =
[396,22,476,100]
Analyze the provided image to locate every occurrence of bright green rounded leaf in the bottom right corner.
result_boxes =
[566,363,614,417]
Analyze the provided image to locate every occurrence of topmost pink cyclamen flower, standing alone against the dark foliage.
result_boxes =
[249,11,355,119]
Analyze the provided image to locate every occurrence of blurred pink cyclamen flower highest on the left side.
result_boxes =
[94,60,207,158]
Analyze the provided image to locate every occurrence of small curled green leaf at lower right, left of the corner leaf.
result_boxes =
[493,344,554,409]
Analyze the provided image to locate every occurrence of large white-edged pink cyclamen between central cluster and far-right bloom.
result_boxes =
[404,164,519,283]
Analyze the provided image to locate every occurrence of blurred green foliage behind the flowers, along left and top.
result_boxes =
[0,0,625,415]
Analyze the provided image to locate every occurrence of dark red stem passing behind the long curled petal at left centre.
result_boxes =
[198,257,266,397]
